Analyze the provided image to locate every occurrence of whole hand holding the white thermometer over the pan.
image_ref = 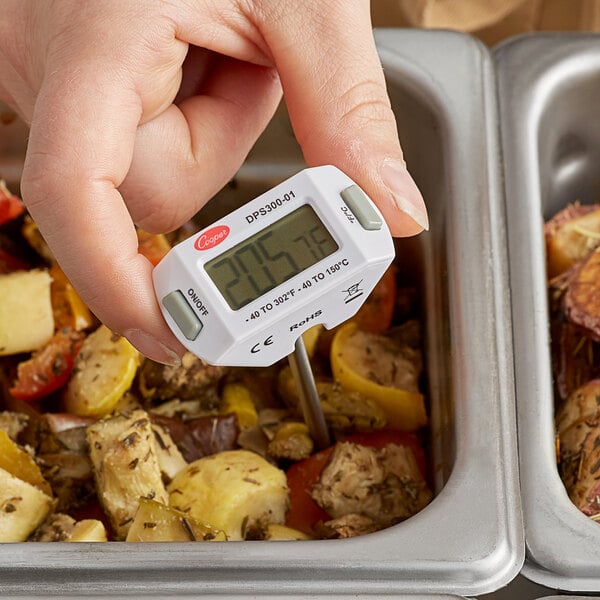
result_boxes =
[0,0,427,363]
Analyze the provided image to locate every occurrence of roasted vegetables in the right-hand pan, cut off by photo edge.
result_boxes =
[545,203,600,520]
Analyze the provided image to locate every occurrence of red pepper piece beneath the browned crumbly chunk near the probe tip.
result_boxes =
[285,429,427,537]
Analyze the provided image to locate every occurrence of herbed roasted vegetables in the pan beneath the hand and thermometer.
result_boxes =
[0,180,432,542]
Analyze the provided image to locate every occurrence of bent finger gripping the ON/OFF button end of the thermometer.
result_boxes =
[21,68,184,363]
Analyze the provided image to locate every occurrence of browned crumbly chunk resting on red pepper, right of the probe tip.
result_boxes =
[312,442,432,529]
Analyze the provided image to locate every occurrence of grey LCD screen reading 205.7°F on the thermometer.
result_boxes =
[204,204,339,310]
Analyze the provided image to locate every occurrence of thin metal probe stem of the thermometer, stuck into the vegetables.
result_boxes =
[288,336,330,450]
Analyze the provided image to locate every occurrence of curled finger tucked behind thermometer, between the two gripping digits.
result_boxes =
[121,57,281,231]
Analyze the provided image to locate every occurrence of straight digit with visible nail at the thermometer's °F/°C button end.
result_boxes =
[256,0,428,236]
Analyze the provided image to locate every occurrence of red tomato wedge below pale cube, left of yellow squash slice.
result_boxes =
[9,328,84,401]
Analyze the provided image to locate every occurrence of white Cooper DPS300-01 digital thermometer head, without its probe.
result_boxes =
[153,166,394,366]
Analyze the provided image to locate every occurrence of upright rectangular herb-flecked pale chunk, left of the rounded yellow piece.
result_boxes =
[87,410,174,539]
